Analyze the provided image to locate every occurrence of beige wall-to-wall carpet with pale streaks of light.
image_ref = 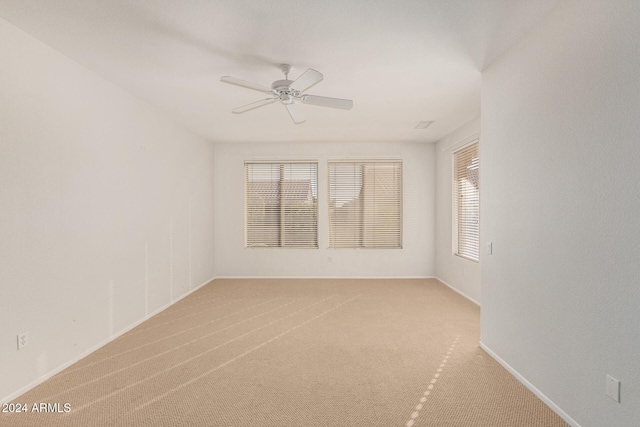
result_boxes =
[0,279,566,427]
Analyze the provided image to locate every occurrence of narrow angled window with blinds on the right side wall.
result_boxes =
[453,142,480,261]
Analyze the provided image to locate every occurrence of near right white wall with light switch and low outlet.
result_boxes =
[481,0,640,427]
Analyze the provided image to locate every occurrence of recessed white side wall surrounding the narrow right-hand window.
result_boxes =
[435,117,482,305]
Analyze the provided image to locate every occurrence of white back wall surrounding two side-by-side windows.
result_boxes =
[214,142,435,277]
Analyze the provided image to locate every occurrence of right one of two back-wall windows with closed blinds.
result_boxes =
[328,160,402,248]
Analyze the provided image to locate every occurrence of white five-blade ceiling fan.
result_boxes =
[220,64,353,124]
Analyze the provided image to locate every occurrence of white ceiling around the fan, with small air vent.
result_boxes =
[0,0,558,142]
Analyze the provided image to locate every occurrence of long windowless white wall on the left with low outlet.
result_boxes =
[0,19,214,401]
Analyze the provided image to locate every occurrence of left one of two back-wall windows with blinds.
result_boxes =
[244,162,318,248]
